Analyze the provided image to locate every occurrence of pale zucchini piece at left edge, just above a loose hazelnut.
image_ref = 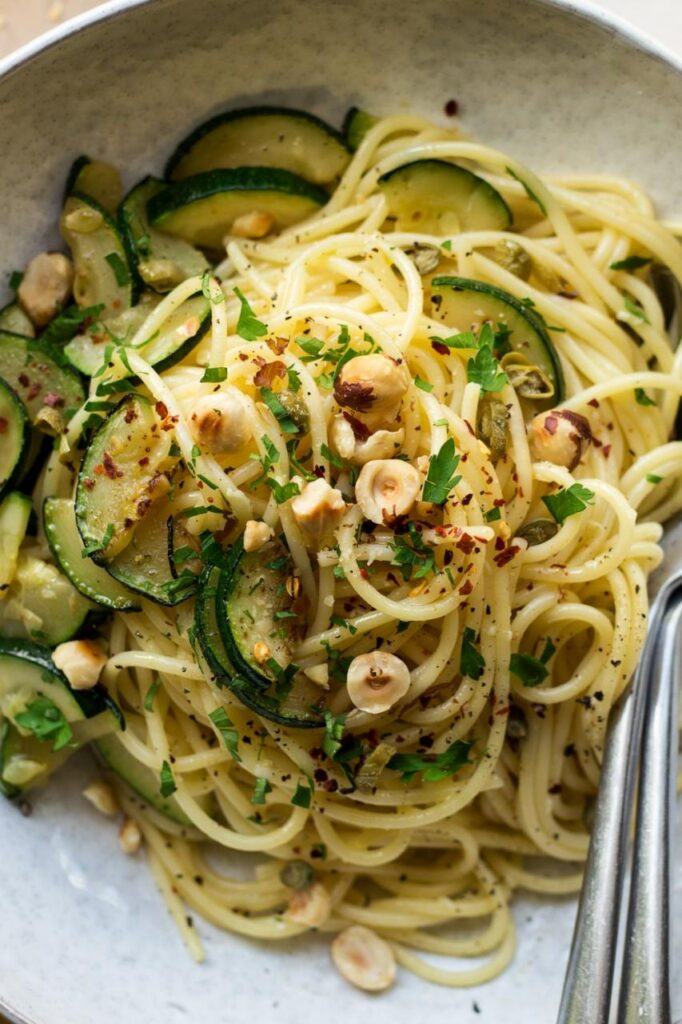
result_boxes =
[0,553,94,647]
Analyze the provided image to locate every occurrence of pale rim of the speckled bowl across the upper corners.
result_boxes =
[0,0,682,1024]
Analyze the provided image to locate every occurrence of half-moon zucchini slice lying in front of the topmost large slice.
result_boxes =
[147,167,328,250]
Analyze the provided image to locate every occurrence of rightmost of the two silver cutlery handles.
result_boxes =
[617,596,682,1024]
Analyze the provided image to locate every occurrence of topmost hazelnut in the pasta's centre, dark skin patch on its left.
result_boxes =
[334,352,410,430]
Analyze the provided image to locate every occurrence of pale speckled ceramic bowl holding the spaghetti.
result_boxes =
[0,0,682,1024]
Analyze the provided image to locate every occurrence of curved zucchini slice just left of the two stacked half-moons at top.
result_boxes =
[119,178,209,293]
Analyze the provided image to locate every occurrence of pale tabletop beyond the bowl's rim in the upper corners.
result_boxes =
[0,0,682,1024]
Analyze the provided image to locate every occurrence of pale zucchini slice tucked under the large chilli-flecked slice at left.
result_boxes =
[43,498,139,611]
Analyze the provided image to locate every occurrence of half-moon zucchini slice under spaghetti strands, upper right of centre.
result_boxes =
[379,160,512,234]
